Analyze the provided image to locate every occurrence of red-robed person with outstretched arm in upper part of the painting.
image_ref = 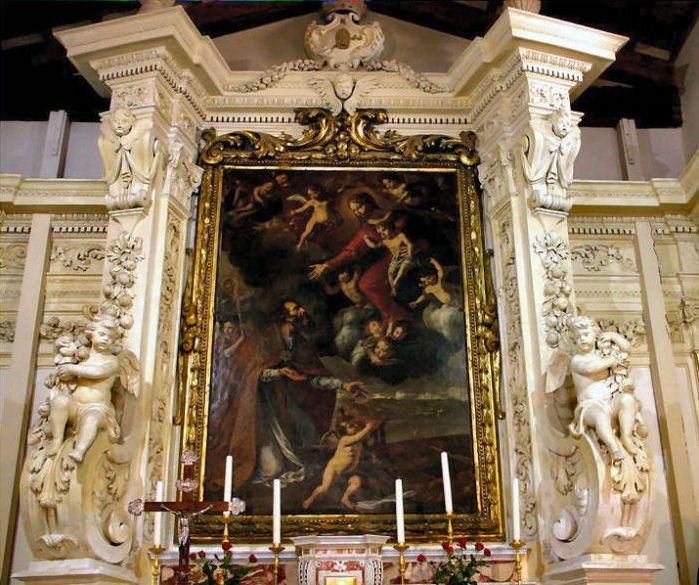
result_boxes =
[309,194,408,324]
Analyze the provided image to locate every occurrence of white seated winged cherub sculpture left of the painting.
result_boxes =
[48,315,138,462]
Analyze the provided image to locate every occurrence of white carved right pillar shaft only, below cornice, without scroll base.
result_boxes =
[471,49,589,554]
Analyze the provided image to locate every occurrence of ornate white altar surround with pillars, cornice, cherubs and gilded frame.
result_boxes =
[2,1,680,585]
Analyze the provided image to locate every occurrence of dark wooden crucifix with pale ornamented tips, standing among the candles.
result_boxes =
[129,451,245,585]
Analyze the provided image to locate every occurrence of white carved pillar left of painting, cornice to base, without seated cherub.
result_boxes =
[15,10,203,583]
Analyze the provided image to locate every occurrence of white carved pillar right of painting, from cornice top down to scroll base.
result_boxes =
[469,10,659,584]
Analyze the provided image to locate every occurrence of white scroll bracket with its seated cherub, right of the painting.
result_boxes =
[546,316,651,558]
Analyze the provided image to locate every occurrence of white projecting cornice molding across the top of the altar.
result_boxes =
[55,6,626,121]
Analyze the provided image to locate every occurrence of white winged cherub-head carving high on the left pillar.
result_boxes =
[98,107,161,209]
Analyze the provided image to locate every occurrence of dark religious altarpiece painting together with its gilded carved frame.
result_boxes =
[176,110,502,541]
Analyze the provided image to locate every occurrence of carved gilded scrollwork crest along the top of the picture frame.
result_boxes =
[201,108,479,166]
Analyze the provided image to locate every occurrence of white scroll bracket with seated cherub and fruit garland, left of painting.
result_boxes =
[21,232,142,563]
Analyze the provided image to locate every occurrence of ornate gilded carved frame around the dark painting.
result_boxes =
[176,109,503,542]
